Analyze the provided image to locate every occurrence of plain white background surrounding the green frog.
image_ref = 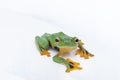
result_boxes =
[0,0,120,80]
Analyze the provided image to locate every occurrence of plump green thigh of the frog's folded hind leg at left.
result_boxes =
[35,36,49,50]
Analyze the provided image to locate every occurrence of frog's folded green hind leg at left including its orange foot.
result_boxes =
[35,36,50,57]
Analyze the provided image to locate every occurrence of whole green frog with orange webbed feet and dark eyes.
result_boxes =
[35,32,94,72]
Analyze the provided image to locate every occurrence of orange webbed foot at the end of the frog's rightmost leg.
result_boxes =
[76,49,94,59]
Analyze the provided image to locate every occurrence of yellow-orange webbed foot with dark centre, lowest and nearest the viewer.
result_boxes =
[66,58,82,72]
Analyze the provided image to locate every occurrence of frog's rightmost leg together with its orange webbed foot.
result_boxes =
[76,40,94,59]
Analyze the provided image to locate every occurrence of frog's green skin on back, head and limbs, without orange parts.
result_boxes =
[35,32,88,69]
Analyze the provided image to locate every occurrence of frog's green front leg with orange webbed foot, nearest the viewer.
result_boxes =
[53,53,82,72]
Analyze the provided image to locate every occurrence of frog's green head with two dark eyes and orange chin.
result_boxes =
[54,35,79,53]
